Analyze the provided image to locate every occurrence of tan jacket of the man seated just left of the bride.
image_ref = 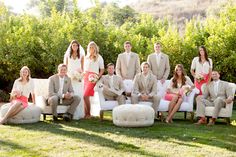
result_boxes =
[48,74,74,98]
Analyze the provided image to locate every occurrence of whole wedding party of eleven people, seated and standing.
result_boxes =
[0,40,233,125]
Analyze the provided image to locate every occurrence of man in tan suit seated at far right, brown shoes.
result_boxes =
[196,71,233,125]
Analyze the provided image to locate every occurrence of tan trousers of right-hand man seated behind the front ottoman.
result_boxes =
[131,94,161,115]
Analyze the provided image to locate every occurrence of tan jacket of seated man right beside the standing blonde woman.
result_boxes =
[101,74,125,95]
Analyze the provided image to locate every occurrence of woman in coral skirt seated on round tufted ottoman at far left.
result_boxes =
[0,66,35,125]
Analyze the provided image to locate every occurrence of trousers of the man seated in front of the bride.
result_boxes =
[48,95,81,117]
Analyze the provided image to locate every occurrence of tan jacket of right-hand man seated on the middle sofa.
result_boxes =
[132,73,157,97]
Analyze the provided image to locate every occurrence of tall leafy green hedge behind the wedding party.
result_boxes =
[0,0,236,100]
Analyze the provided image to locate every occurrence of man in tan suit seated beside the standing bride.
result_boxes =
[48,64,81,121]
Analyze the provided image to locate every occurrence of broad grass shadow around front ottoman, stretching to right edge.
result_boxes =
[62,112,236,152]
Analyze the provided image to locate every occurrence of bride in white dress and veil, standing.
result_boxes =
[64,40,85,119]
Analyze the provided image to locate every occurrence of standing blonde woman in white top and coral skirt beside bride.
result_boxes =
[84,41,104,119]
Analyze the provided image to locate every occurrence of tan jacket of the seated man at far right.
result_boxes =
[203,80,233,101]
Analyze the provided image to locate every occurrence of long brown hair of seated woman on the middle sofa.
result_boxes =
[172,64,186,88]
